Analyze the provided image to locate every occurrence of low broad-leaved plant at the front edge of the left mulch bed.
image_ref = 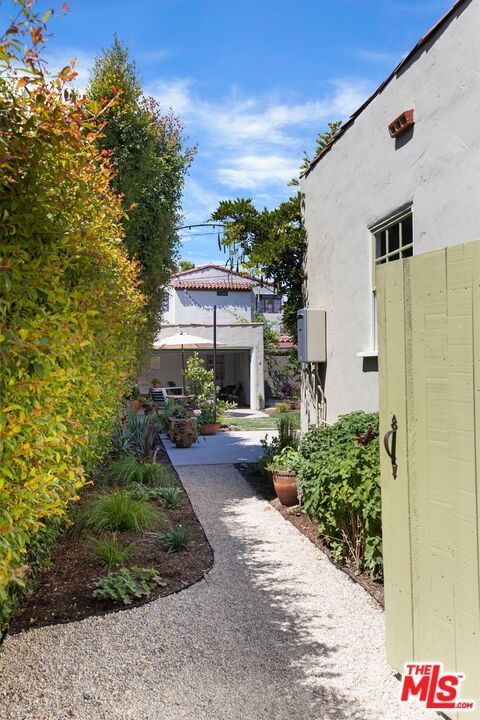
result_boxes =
[92,567,167,605]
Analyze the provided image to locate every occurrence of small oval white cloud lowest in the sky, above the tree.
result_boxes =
[218,155,299,190]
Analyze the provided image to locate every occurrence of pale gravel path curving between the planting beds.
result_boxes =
[0,465,432,720]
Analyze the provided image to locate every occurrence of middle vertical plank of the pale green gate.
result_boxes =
[405,250,455,668]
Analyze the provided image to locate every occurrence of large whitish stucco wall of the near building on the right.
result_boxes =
[301,0,480,427]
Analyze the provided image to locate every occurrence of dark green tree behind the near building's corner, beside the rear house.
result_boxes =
[211,122,340,335]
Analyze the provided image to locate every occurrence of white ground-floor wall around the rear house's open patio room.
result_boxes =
[151,323,264,409]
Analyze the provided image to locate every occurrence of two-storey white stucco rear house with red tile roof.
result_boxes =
[140,264,281,409]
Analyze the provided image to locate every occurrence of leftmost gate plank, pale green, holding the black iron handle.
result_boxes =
[376,263,413,672]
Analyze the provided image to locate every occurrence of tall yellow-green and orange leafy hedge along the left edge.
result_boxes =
[0,5,145,627]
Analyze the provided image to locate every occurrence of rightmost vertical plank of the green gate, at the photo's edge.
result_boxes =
[447,242,480,717]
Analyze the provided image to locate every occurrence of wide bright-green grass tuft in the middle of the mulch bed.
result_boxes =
[77,490,163,533]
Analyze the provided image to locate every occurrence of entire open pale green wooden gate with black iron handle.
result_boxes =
[376,240,480,720]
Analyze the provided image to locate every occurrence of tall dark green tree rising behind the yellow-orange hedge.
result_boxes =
[87,37,195,343]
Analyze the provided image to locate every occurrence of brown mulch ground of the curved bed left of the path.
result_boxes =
[9,452,213,633]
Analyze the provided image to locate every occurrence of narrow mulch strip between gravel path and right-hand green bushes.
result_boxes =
[236,463,384,607]
